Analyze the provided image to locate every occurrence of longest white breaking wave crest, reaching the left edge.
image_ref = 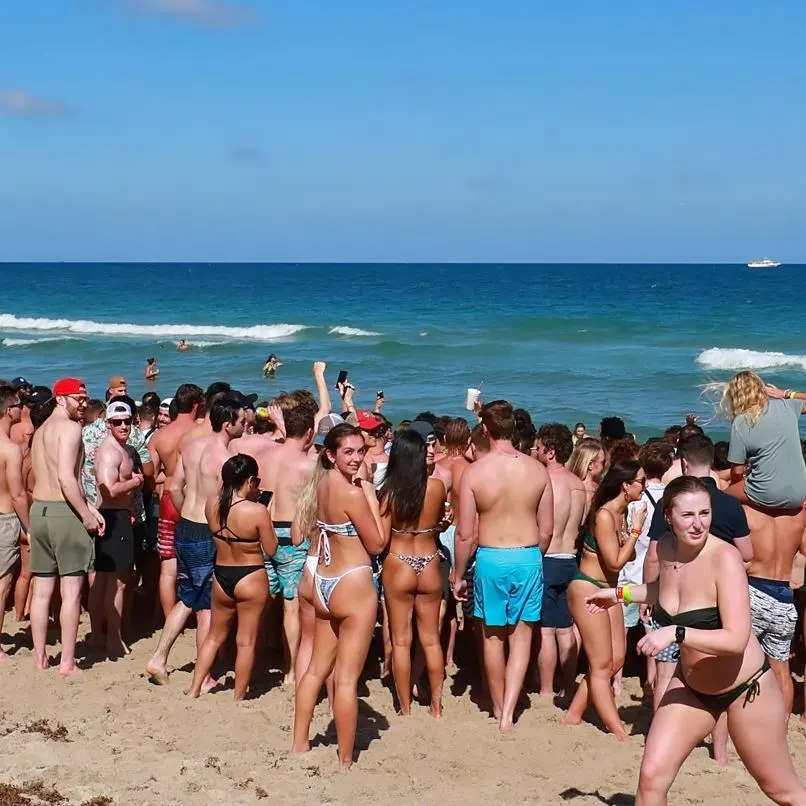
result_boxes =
[0,313,308,341]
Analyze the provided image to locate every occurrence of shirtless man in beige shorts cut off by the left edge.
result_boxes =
[0,386,28,661]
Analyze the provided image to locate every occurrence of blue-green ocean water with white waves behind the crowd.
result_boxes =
[0,263,806,438]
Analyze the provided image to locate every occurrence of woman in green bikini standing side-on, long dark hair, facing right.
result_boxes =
[562,460,646,740]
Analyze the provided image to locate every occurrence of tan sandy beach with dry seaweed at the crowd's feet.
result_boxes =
[0,613,806,806]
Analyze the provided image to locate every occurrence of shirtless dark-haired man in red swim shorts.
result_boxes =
[148,383,204,618]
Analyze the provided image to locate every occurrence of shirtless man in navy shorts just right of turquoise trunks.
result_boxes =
[536,423,585,697]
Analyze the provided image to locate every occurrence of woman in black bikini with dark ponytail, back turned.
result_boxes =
[188,453,277,702]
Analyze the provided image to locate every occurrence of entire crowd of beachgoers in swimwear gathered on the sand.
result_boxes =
[0,370,806,806]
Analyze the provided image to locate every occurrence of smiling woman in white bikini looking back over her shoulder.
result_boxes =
[292,423,385,767]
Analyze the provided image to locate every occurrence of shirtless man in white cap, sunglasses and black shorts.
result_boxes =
[88,402,143,657]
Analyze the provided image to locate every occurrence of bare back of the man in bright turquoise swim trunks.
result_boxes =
[460,450,554,548]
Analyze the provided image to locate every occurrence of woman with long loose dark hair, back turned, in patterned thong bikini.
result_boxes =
[378,431,447,718]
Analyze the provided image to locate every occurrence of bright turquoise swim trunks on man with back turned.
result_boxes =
[473,546,543,627]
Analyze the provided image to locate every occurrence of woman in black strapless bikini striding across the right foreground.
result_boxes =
[587,476,806,806]
